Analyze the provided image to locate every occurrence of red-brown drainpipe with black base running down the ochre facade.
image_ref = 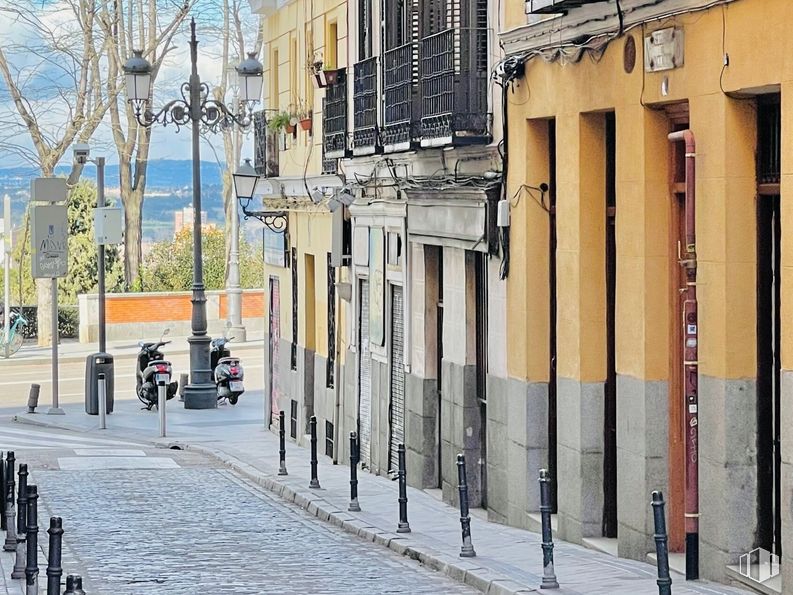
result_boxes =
[669,130,699,580]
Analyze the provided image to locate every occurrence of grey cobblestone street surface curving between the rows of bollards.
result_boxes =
[33,450,476,595]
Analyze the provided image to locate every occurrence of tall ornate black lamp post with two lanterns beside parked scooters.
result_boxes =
[124,19,263,409]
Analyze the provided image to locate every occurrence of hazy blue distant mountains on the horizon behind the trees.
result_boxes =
[0,159,232,241]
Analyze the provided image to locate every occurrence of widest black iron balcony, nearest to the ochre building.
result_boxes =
[421,28,491,147]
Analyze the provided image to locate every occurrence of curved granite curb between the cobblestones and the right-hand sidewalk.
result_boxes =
[179,441,540,595]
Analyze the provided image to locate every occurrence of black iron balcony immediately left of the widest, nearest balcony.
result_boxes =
[381,43,419,153]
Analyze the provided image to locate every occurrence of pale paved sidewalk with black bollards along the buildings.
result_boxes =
[15,391,746,595]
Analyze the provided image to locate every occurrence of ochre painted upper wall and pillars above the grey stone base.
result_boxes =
[507,0,793,381]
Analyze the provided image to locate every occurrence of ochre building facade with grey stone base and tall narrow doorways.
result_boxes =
[501,0,793,592]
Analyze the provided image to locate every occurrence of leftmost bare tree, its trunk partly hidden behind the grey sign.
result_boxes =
[0,0,110,345]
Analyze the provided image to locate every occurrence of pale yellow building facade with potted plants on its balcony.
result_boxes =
[251,0,347,456]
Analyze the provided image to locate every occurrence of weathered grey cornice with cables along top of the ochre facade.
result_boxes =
[500,0,737,55]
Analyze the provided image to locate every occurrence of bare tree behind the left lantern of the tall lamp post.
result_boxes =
[100,0,195,288]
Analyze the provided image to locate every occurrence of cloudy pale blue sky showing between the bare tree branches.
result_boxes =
[0,0,257,168]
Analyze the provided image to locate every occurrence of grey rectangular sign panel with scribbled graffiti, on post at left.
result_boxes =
[30,205,69,279]
